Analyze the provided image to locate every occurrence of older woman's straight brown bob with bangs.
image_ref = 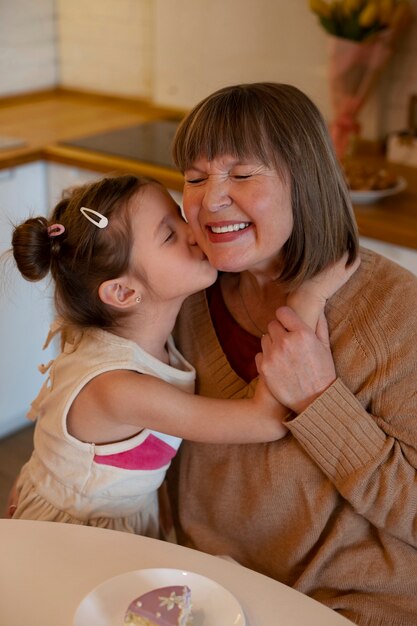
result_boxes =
[173,83,359,289]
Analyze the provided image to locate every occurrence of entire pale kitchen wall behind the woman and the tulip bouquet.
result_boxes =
[0,0,417,138]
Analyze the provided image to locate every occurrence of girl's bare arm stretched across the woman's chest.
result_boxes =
[67,370,289,444]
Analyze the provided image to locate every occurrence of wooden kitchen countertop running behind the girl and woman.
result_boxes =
[0,89,417,249]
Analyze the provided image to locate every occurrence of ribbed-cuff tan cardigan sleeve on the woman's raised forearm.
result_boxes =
[287,379,417,547]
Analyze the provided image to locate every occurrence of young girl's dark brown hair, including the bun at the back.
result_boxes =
[12,175,159,328]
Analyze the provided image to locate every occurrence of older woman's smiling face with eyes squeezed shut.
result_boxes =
[183,155,293,273]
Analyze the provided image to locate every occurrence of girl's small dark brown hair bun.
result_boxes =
[12,217,54,281]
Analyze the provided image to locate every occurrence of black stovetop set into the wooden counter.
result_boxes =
[60,120,179,168]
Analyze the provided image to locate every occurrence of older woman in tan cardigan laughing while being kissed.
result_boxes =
[170,83,417,626]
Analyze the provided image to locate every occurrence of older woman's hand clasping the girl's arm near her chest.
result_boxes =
[256,307,336,413]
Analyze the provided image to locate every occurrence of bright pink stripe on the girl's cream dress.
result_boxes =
[94,434,177,470]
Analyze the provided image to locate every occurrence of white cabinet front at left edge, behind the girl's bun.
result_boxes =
[0,162,53,437]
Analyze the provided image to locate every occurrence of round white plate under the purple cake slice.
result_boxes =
[73,568,246,626]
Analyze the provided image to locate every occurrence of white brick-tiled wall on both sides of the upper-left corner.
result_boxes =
[0,0,154,98]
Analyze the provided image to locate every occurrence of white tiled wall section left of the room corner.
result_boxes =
[0,0,58,96]
